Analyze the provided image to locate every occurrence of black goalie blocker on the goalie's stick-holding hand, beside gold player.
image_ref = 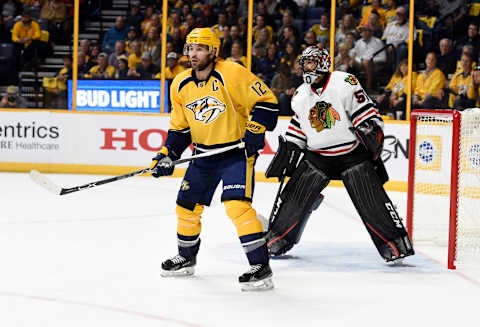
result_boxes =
[265,135,302,178]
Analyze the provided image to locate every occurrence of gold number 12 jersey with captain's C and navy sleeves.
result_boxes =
[169,61,278,151]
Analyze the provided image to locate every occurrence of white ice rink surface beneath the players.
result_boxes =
[0,173,480,327]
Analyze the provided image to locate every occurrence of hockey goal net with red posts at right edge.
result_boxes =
[407,109,480,269]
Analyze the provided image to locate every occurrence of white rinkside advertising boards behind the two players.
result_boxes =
[0,110,410,187]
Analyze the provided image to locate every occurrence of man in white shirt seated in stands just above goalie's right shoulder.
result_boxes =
[353,25,387,93]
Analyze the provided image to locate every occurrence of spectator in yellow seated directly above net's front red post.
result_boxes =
[446,54,477,110]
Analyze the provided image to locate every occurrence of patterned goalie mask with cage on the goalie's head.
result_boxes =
[298,45,332,84]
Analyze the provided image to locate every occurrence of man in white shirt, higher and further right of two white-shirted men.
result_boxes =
[382,7,416,67]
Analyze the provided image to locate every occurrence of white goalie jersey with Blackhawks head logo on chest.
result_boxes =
[286,71,383,156]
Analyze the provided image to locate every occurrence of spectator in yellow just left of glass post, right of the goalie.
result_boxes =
[377,59,418,119]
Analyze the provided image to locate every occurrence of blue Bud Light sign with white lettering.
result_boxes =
[68,80,168,113]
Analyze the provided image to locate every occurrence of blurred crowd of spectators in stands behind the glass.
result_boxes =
[0,0,480,119]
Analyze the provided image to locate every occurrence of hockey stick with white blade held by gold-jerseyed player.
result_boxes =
[30,143,245,195]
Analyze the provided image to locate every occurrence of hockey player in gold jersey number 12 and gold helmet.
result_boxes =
[152,28,278,290]
